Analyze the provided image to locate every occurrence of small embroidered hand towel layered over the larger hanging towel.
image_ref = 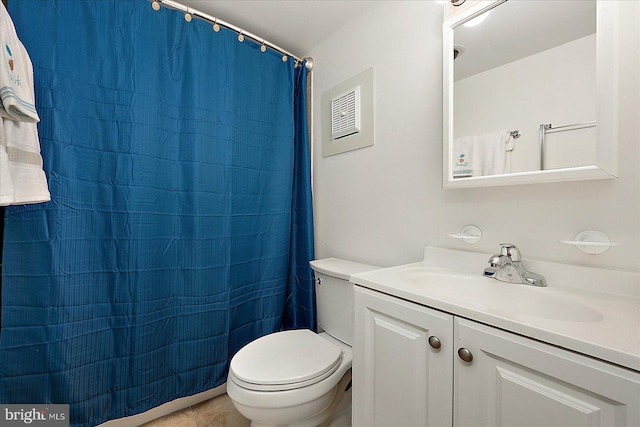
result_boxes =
[0,5,40,123]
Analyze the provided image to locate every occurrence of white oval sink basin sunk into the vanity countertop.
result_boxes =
[398,267,603,323]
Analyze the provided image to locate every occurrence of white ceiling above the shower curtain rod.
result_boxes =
[178,0,379,57]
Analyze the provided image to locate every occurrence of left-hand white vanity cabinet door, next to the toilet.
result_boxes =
[353,286,453,427]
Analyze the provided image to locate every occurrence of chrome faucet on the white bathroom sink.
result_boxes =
[484,243,547,286]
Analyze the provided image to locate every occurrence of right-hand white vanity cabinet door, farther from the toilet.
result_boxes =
[454,318,640,427]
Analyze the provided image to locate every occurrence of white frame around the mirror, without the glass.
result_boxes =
[442,0,619,188]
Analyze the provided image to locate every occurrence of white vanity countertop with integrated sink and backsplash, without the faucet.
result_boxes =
[350,247,640,372]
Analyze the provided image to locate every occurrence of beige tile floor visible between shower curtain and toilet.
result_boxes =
[143,394,251,427]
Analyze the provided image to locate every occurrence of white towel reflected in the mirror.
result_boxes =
[452,131,515,178]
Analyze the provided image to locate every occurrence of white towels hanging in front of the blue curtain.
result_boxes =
[0,5,51,206]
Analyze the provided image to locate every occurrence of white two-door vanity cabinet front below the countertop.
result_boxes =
[353,286,640,427]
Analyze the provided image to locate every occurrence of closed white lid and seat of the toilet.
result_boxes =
[230,329,342,390]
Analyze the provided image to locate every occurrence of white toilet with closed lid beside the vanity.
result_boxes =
[227,258,378,427]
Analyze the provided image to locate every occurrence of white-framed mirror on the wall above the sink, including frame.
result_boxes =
[443,0,618,188]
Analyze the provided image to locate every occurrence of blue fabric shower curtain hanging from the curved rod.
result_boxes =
[0,0,316,426]
